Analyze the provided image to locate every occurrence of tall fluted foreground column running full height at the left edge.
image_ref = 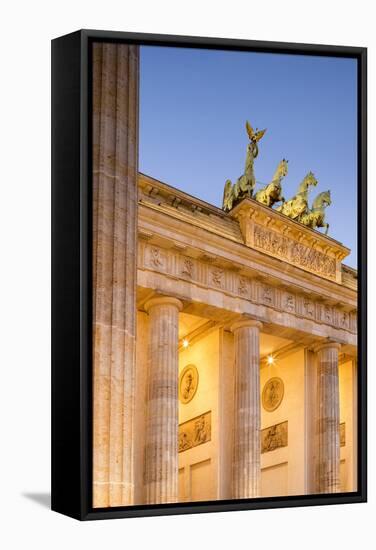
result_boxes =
[93,42,139,507]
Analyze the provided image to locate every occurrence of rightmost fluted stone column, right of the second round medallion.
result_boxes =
[315,342,341,493]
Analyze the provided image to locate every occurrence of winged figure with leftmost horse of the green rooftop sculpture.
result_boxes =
[222,120,266,212]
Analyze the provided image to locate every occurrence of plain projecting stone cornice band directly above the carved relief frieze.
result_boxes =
[138,204,357,311]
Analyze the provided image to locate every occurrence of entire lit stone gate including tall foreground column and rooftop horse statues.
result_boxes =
[93,44,357,507]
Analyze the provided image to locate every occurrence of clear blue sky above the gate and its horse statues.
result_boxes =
[139,46,357,267]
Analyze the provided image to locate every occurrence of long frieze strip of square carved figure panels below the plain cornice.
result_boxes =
[138,243,357,333]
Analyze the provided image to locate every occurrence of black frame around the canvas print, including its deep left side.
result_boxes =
[52,30,367,520]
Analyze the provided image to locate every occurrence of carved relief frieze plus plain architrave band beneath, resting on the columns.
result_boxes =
[138,236,357,342]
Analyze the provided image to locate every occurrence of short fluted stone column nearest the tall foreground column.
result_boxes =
[145,297,182,504]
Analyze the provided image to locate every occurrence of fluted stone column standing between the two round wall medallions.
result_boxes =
[231,320,262,498]
